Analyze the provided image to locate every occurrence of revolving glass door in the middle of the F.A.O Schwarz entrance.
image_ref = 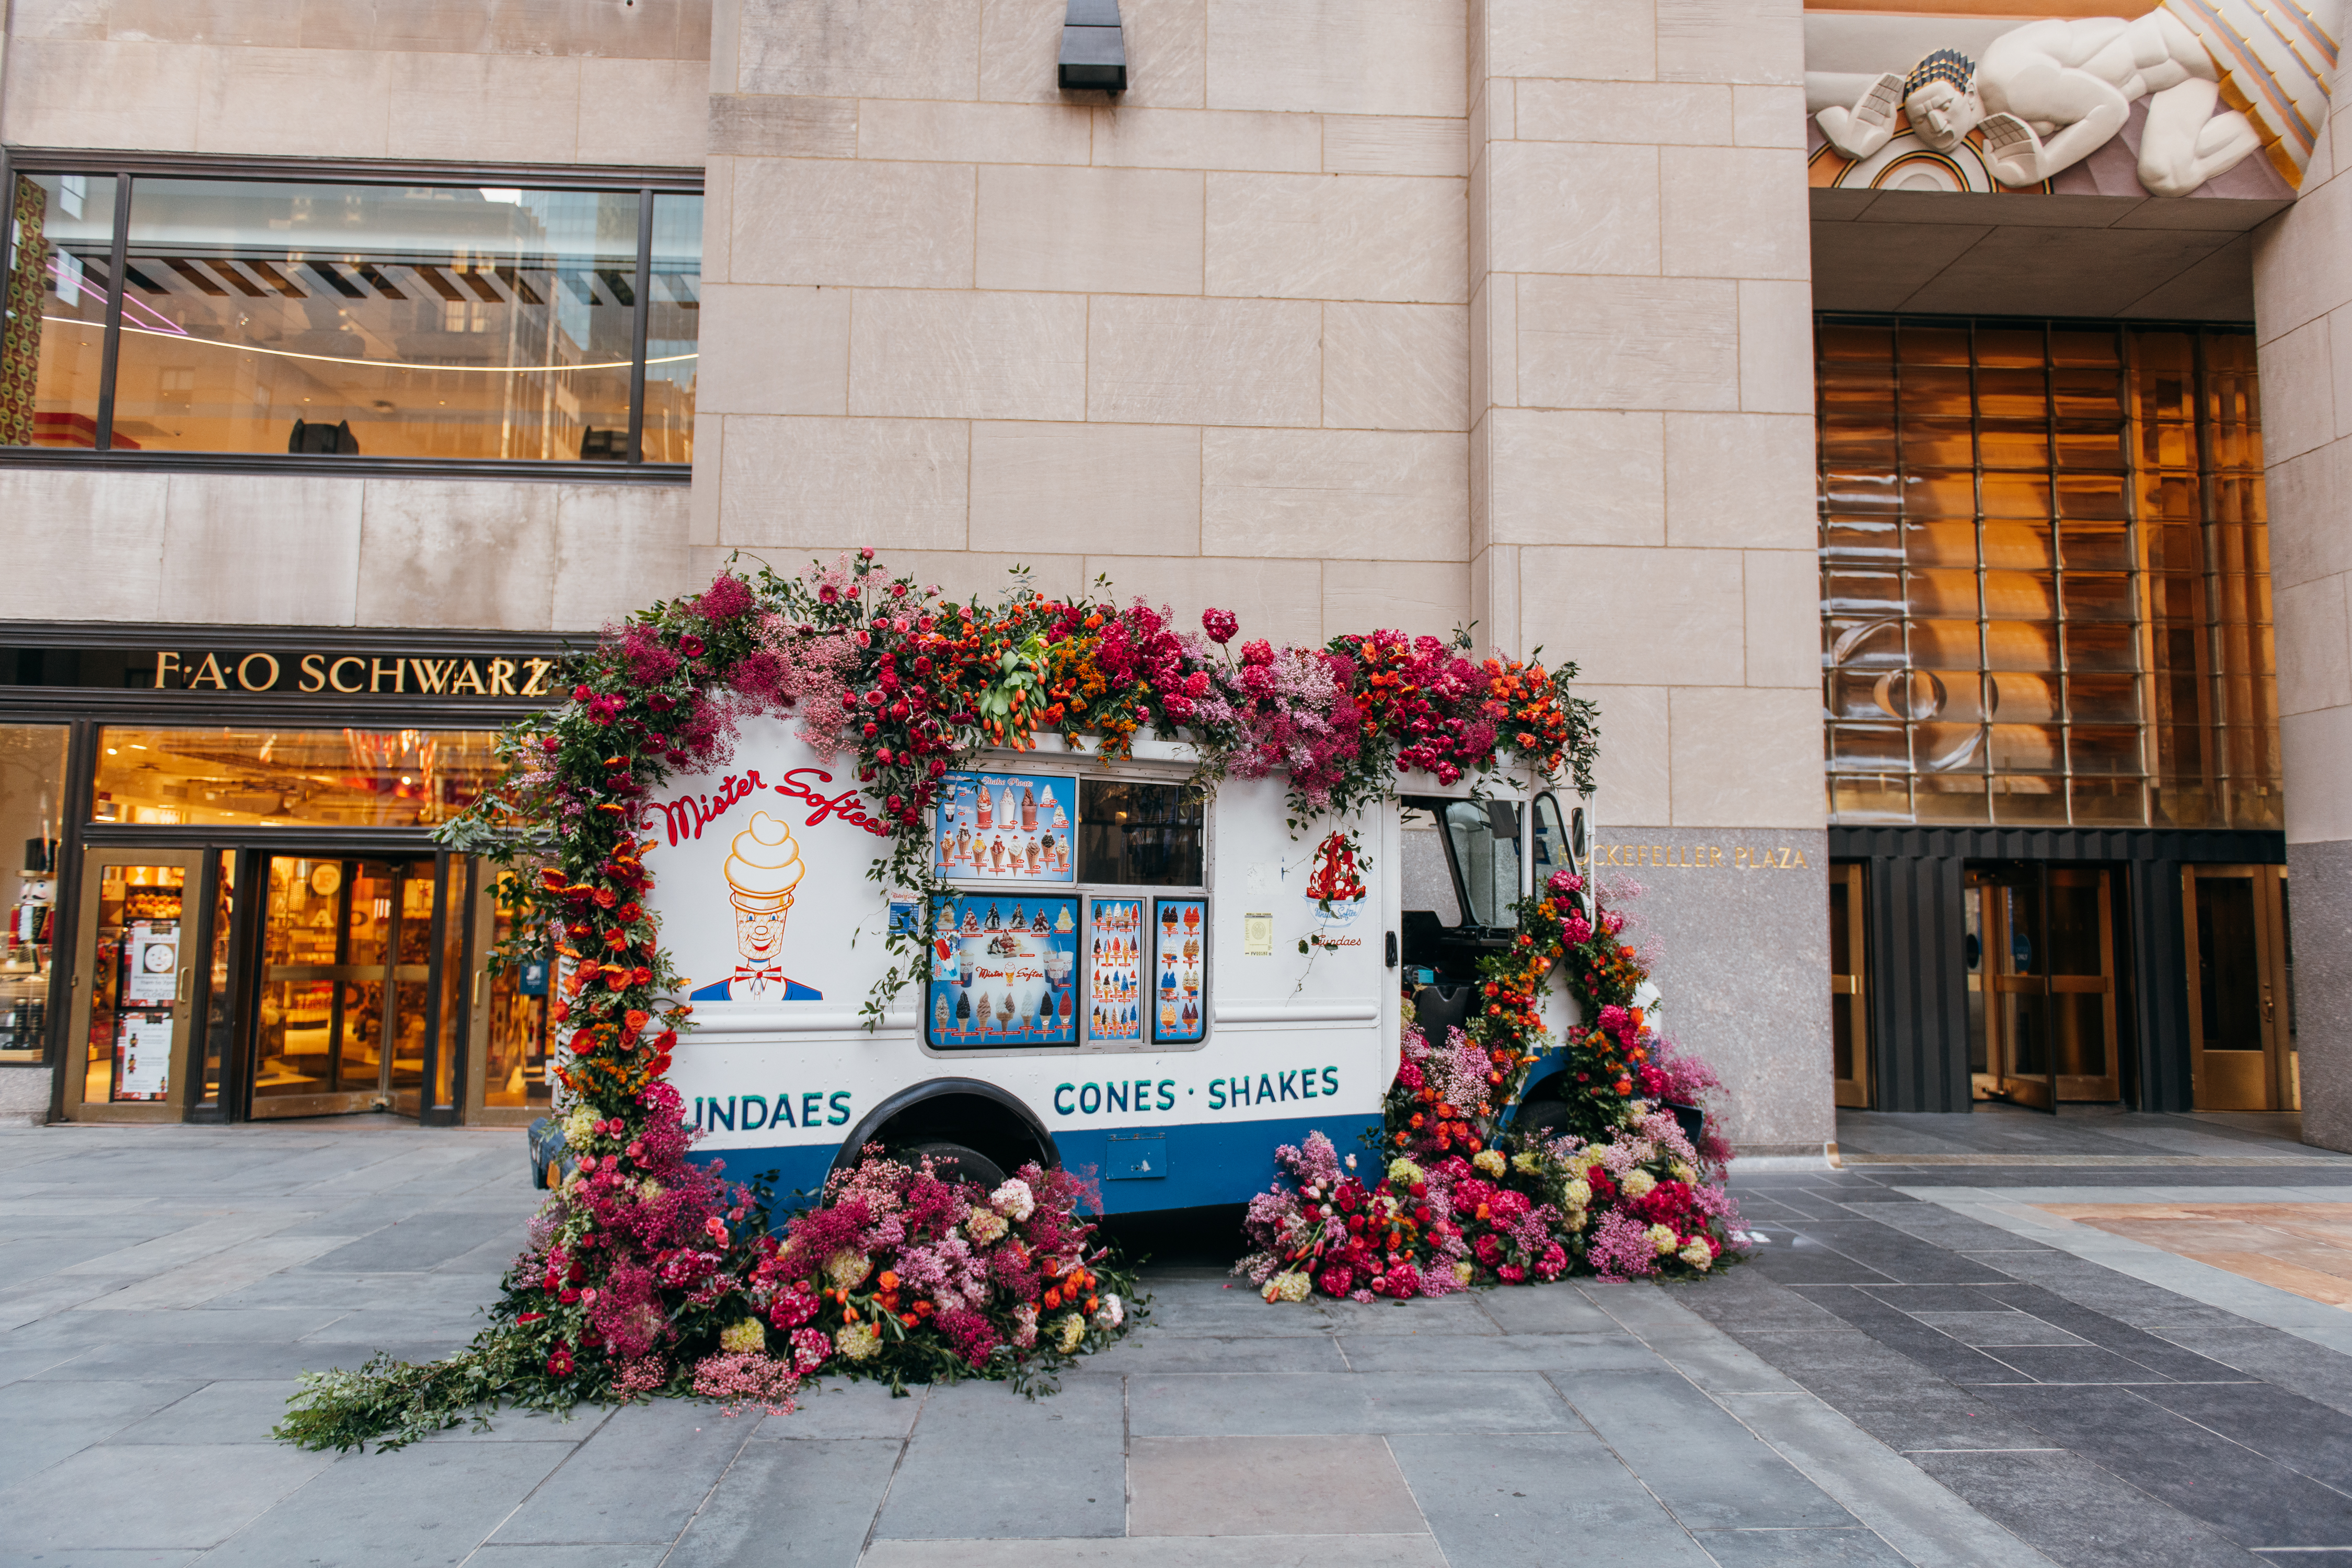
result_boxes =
[247,856,440,1121]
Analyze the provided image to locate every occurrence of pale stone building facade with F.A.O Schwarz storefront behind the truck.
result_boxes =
[0,0,2352,1152]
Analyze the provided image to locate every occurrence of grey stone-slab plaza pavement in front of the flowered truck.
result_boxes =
[0,1116,2352,1568]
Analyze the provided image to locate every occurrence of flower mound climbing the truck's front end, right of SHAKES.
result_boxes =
[1235,872,1738,1302]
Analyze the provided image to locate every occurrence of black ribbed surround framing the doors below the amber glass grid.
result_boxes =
[1830,827,2286,1112]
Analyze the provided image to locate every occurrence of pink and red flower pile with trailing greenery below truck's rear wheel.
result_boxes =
[278,1133,1138,1448]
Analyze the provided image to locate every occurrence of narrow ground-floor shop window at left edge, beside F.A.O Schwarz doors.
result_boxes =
[0,724,66,1063]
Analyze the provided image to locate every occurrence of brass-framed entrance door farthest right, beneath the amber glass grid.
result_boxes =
[2181,865,2303,1110]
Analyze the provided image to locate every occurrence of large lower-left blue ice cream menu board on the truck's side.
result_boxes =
[925,893,1077,1051]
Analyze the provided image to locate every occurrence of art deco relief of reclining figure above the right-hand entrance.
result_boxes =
[1816,0,2336,195]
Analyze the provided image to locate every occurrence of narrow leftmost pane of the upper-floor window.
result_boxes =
[0,174,116,447]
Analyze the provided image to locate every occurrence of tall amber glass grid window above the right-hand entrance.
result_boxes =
[1816,317,2281,827]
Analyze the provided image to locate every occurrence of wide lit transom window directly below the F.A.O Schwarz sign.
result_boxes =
[92,727,499,827]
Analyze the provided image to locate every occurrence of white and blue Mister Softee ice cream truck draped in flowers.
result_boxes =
[616,719,1585,1213]
